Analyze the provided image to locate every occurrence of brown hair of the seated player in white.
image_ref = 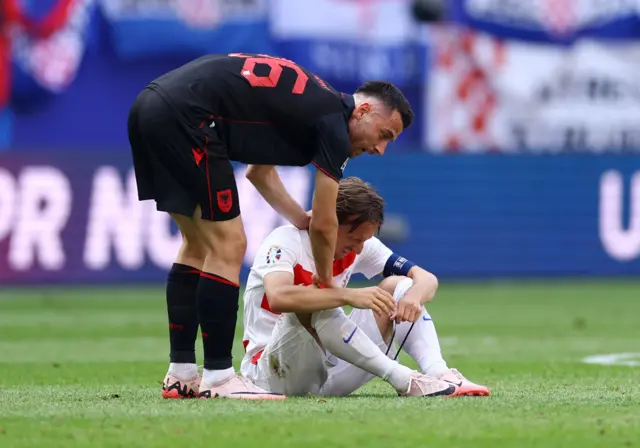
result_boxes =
[336,177,384,232]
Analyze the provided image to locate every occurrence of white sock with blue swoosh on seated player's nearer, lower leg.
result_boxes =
[311,308,413,392]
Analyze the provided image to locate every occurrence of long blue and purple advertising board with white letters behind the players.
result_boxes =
[0,151,640,284]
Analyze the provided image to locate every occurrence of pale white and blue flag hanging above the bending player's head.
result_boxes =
[269,0,425,85]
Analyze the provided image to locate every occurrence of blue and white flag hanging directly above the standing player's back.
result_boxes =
[98,0,272,59]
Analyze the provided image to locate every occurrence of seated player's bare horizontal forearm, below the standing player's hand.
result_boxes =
[267,286,347,313]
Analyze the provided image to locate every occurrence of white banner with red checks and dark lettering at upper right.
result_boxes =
[424,28,640,153]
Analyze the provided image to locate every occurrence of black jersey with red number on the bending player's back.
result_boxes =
[149,53,355,180]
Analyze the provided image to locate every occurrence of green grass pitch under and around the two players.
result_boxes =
[0,281,640,448]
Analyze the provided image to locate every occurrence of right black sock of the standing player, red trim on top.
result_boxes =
[196,272,240,370]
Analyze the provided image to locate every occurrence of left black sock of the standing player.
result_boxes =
[166,263,200,364]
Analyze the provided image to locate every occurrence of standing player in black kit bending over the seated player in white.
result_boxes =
[128,54,413,399]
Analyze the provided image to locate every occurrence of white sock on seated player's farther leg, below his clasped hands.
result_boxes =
[393,278,449,377]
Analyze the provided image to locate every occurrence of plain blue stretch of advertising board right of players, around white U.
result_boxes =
[349,155,640,277]
